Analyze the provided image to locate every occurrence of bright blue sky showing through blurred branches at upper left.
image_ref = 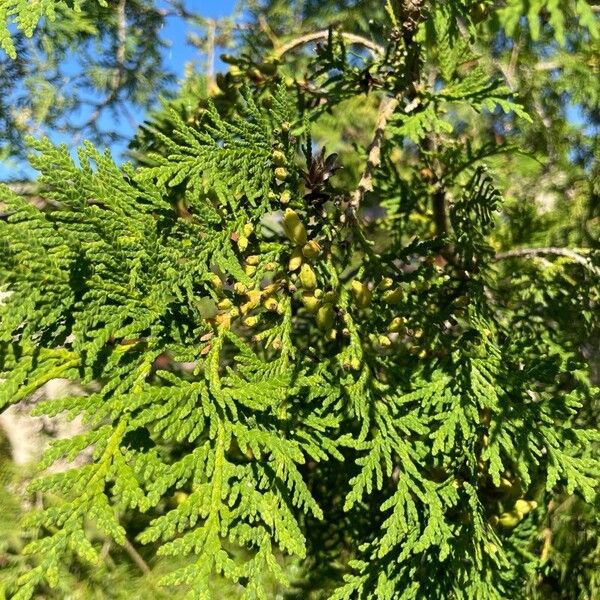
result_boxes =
[0,0,237,180]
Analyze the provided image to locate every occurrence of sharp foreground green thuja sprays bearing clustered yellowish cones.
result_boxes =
[0,0,600,600]
